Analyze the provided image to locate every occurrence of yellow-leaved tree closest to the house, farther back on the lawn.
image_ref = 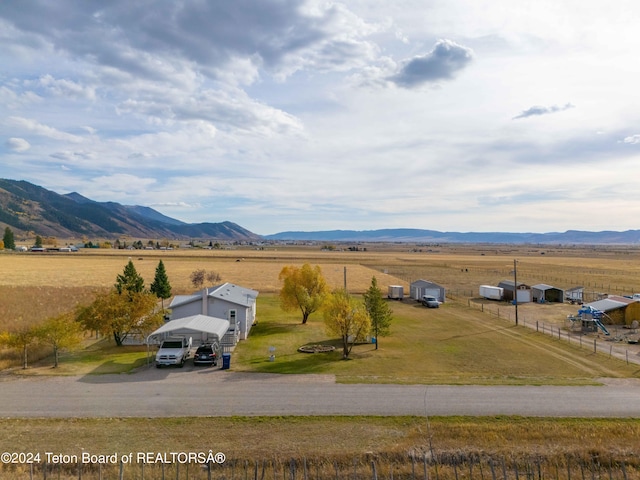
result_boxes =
[278,263,329,324]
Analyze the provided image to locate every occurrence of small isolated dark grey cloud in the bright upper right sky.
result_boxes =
[391,40,473,88]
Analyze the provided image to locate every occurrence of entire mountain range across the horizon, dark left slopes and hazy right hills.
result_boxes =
[0,179,640,245]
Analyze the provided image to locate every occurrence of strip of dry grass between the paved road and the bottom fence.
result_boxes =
[0,416,640,467]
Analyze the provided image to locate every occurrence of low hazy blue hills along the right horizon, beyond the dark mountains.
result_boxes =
[263,228,640,245]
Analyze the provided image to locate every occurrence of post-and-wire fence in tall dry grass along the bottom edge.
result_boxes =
[0,452,640,480]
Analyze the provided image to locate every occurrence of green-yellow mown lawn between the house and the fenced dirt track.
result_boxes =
[232,295,639,385]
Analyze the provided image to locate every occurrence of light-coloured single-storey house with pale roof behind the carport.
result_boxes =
[169,283,258,345]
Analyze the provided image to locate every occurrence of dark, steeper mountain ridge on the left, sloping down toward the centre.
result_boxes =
[0,179,261,241]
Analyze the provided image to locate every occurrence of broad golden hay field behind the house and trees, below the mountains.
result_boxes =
[0,244,640,329]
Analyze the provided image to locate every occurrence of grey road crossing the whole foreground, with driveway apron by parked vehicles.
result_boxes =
[5,365,640,418]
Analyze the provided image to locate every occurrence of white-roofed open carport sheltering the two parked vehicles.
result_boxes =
[146,314,230,364]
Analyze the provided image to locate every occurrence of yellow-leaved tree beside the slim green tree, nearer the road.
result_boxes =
[322,289,371,360]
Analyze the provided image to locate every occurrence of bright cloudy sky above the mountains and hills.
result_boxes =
[0,0,640,235]
